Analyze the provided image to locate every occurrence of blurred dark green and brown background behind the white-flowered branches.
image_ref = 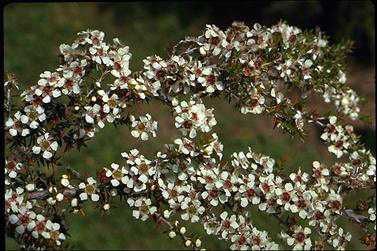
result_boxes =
[4,1,376,249]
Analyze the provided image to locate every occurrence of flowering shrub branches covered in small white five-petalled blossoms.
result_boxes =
[4,22,376,250]
